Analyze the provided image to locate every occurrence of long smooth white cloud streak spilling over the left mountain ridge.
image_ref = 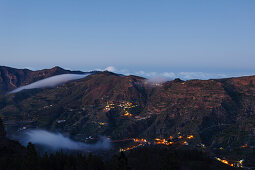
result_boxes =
[9,74,88,94]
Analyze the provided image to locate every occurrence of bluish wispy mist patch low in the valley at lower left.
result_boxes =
[19,130,111,152]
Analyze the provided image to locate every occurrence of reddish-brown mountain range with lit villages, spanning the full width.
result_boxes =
[0,67,255,164]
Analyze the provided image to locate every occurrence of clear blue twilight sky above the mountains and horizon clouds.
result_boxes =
[0,0,255,79]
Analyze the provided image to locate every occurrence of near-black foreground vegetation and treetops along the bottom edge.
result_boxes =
[0,143,237,170]
